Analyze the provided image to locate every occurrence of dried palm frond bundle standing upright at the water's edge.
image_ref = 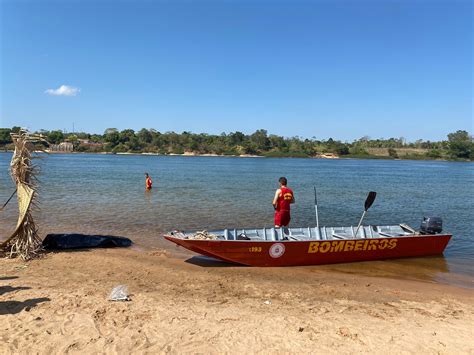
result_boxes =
[0,130,48,260]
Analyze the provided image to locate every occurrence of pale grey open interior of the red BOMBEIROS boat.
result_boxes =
[173,224,419,241]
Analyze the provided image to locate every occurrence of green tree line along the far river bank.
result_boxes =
[0,127,474,160]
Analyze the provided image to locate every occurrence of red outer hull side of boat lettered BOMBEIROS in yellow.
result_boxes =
[165,234,451,266]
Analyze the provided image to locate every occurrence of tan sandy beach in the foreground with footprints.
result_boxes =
[0,249,474,354]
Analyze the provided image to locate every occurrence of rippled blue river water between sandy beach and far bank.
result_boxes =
[0,153,474,287]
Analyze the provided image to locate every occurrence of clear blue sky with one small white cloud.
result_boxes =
[0,0,473,141]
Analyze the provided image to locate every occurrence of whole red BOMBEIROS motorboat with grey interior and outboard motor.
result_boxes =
[165,222,451,266]
